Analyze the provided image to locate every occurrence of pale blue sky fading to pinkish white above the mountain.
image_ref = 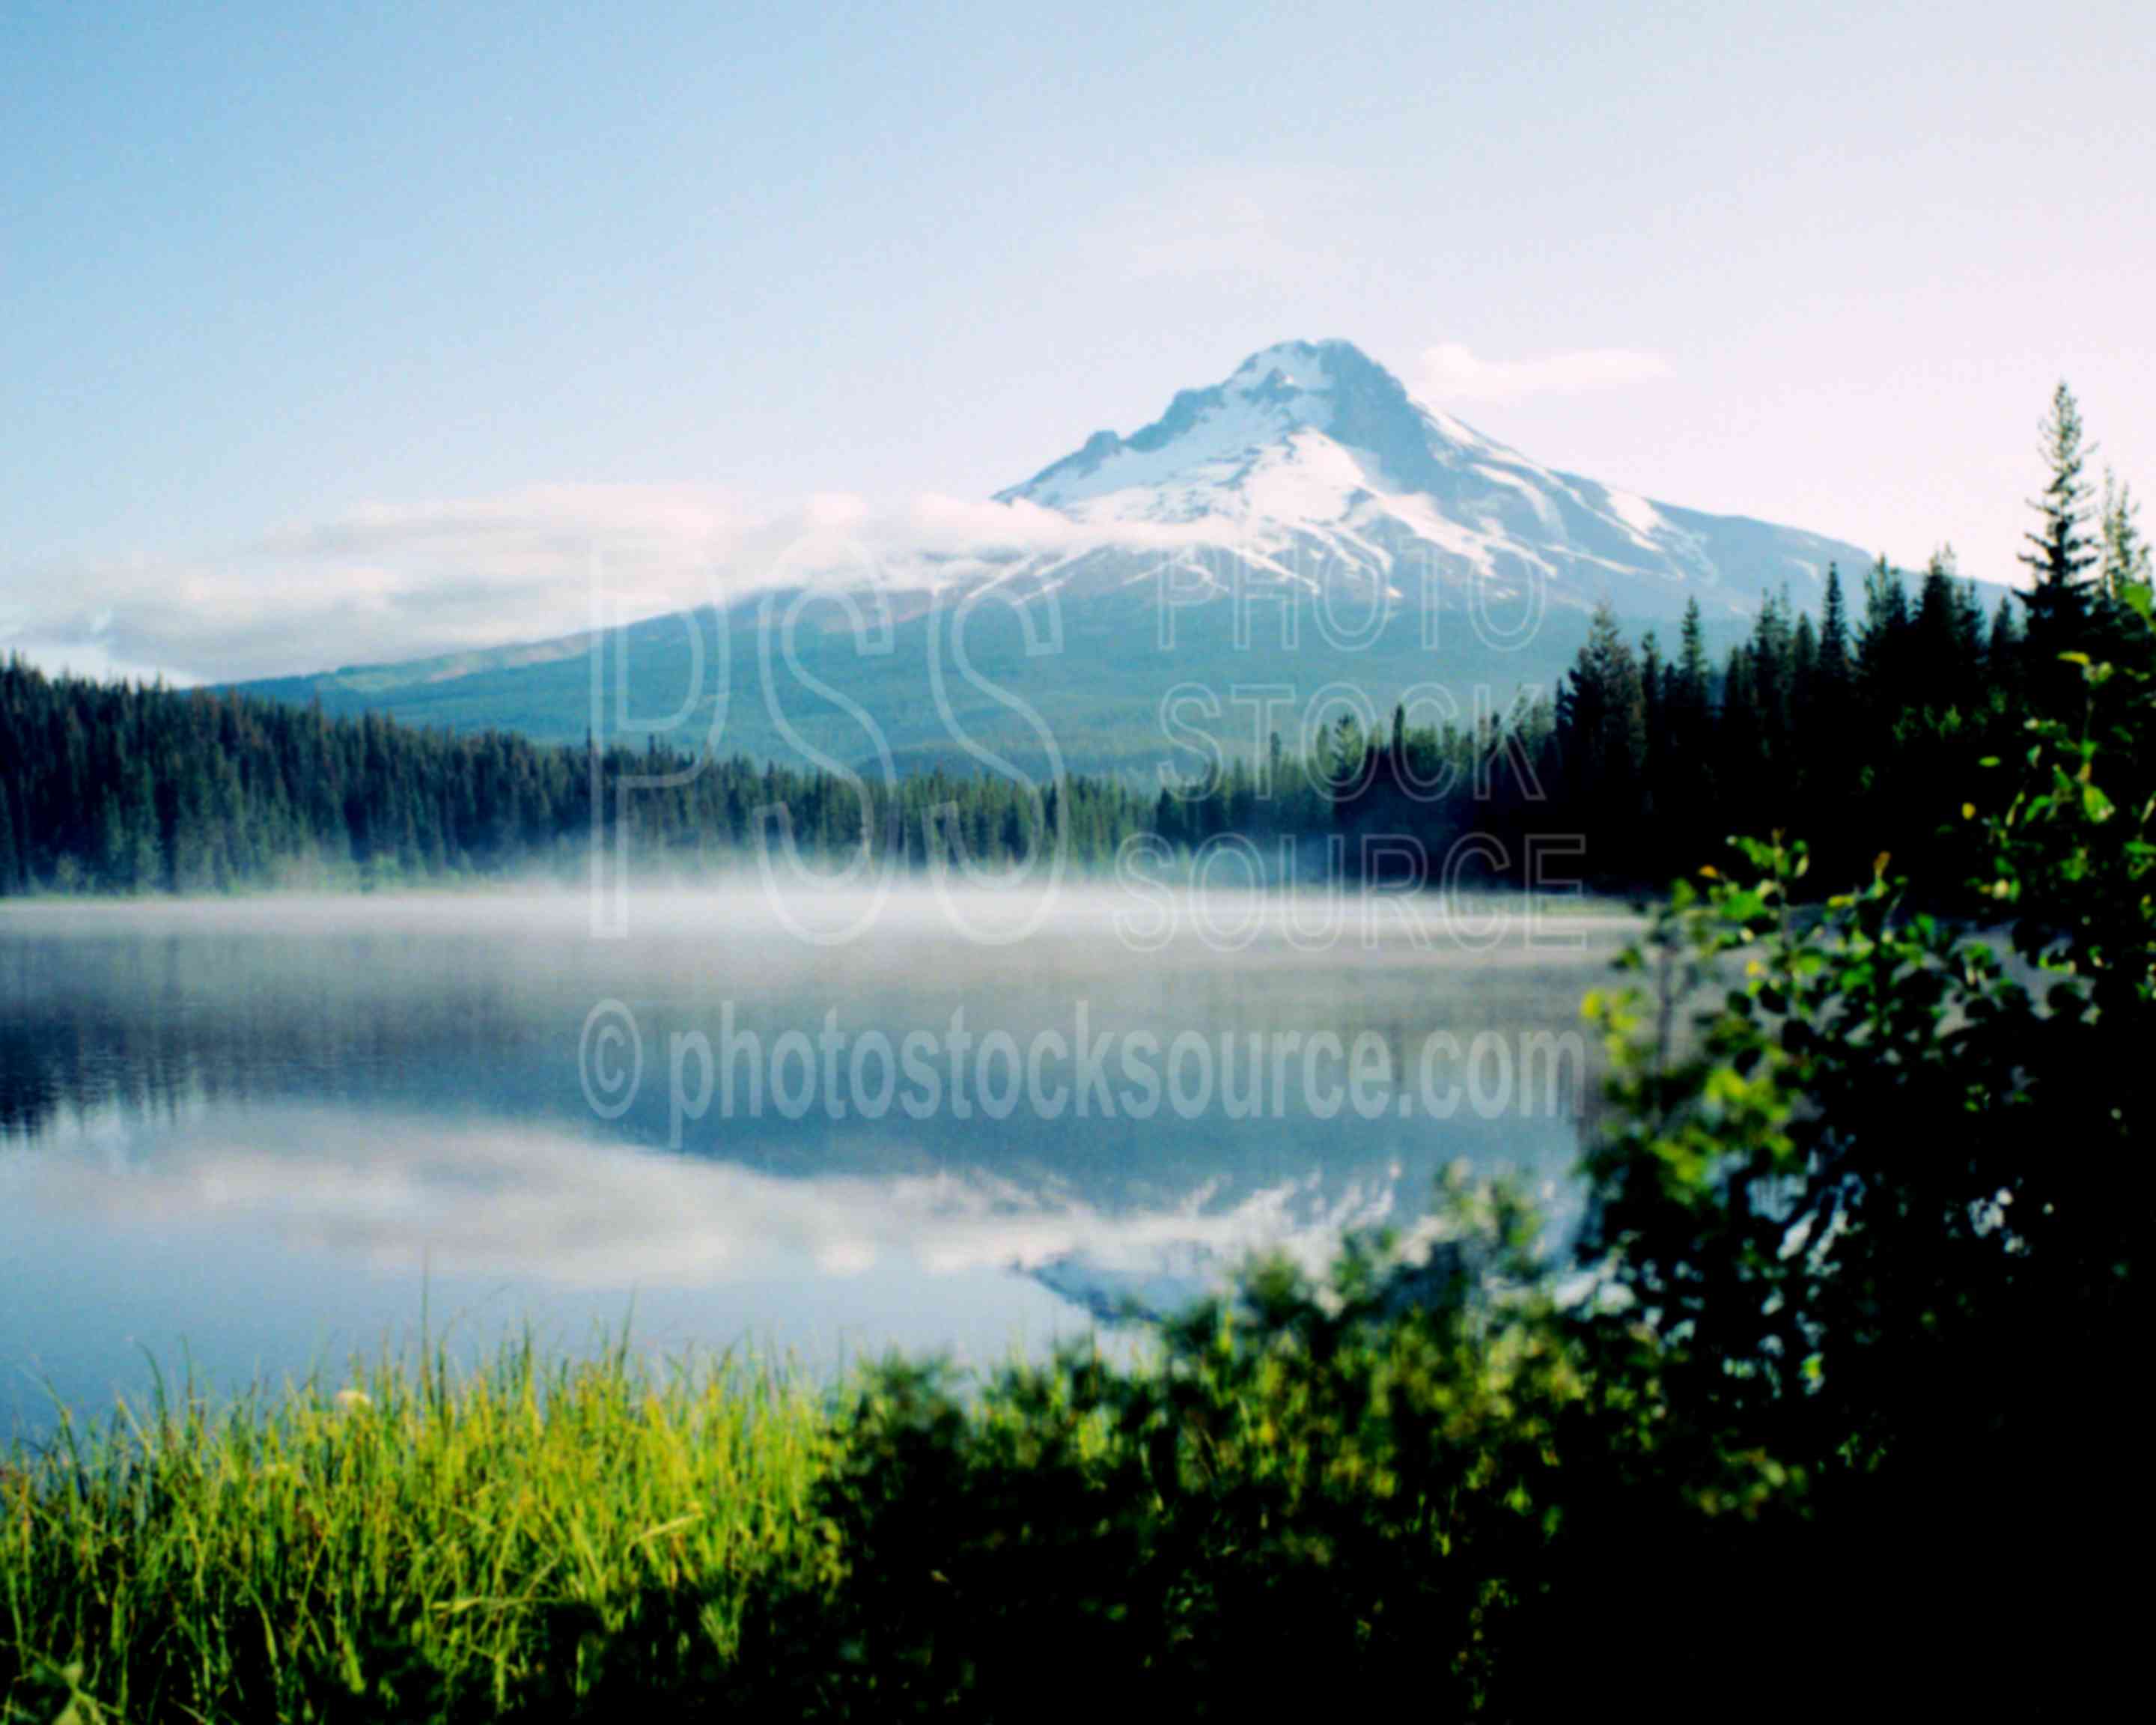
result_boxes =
[0,0,2156,675]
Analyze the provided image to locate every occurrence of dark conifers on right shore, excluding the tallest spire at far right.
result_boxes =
[1151,552,2061,886]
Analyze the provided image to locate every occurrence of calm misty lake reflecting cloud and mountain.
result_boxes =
[0,886,1634,1438]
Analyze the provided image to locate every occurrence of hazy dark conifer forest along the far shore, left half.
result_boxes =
[0,662,1149,892]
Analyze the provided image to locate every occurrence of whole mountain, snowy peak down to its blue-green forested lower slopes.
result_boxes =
[240,341,1869,774]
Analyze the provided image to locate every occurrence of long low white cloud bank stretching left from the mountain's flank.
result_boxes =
[0,485,1233,684]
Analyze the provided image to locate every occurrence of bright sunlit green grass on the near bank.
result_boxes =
[0,1343,830,1721]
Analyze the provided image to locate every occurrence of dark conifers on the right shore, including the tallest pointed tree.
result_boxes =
[1333,384,2149,886]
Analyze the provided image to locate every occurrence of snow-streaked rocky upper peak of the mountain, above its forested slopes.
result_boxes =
[998,341,1867,617]
